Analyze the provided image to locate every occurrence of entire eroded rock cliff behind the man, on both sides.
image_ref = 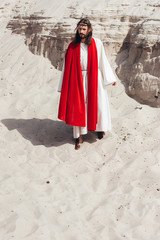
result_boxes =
[3,0,160,107]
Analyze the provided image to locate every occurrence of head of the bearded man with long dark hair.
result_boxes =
[74,18,92,45]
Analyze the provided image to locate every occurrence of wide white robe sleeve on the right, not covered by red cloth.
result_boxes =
[100,43,117,85]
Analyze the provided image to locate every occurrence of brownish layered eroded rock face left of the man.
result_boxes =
[7,15,73,69]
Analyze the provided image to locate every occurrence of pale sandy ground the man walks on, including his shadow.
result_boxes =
[0,14,160,240]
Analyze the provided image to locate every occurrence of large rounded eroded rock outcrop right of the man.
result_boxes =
[116,21,160,107]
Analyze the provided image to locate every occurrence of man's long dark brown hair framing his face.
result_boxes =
[73,18,93,46]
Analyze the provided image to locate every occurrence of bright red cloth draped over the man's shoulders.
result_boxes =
[58,38,98,131]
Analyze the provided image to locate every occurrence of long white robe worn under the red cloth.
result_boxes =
[58,38,117,138]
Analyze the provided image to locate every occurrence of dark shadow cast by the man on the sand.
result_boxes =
[1,118,96,147]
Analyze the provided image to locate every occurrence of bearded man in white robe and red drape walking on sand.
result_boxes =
[58,18,116,150]
